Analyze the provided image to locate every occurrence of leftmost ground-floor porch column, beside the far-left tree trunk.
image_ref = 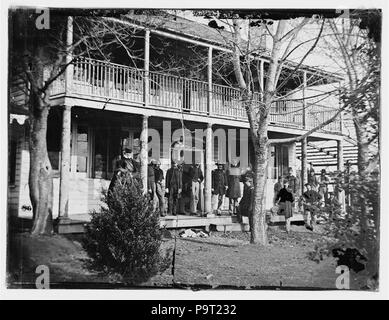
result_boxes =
[58,106,71,220]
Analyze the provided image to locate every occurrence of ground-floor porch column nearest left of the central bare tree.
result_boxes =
[204,123,212,214]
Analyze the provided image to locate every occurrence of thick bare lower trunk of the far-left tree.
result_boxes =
[29,98,53,234]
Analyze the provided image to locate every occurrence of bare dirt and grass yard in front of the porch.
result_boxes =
[8,226,365,289]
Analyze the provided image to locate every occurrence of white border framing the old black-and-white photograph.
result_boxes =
[0,0,389,300]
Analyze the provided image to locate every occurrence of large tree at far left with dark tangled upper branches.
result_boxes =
[10,8,167,234]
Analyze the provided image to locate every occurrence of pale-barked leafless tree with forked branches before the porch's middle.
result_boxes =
[206,11,344,245]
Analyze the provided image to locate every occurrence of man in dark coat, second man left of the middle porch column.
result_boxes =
[166,161,182,215]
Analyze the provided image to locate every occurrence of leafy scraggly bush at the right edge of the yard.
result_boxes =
[311,172,380,286]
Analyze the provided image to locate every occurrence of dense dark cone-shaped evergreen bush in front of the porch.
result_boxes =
[84,174,163,284]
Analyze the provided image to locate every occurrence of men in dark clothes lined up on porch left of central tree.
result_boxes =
[109,148,254,217]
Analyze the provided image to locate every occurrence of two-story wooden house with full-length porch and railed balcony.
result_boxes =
[8,11,343,231]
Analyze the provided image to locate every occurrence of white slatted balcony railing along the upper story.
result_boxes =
[54,58,340,133]
